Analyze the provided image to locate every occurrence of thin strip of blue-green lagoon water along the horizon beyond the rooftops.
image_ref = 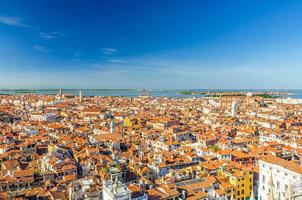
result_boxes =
[0,89,302,98]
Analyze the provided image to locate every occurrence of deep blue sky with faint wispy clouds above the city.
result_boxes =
[0,0,302,89]
